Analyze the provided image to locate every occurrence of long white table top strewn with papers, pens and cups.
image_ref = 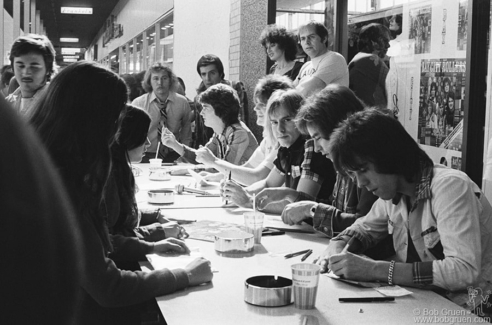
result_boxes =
[137,165,483,325]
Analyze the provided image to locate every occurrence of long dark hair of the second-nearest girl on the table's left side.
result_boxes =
[111,104,150,233]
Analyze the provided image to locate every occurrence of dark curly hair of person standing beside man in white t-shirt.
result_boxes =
[260,24,297,61]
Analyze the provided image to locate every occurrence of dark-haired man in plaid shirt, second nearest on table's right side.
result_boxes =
[282,84,394,258]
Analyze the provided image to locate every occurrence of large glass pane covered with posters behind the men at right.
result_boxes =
[348,0,469,169]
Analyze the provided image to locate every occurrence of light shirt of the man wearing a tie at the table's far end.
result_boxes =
[132,91,191,152]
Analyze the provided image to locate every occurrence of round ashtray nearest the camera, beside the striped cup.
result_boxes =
[244,275,293,307]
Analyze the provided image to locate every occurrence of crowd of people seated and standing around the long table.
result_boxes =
[0,21,492,324]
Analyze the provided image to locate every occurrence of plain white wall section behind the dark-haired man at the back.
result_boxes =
[173,0,231,99]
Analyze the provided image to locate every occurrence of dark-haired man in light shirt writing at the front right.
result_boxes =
[318,110,492,309]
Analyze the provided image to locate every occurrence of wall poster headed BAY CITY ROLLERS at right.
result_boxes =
[418,59,466,168]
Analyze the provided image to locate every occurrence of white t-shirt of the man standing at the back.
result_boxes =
[297,51,349,87]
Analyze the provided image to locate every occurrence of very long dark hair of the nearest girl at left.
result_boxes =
[30,61,128,250]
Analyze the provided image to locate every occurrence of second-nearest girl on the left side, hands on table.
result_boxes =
[105,104,186,261]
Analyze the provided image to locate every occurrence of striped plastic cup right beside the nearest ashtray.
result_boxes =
[291,263,321,309]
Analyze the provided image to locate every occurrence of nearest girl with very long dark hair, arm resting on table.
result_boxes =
[30,61,212,324]
